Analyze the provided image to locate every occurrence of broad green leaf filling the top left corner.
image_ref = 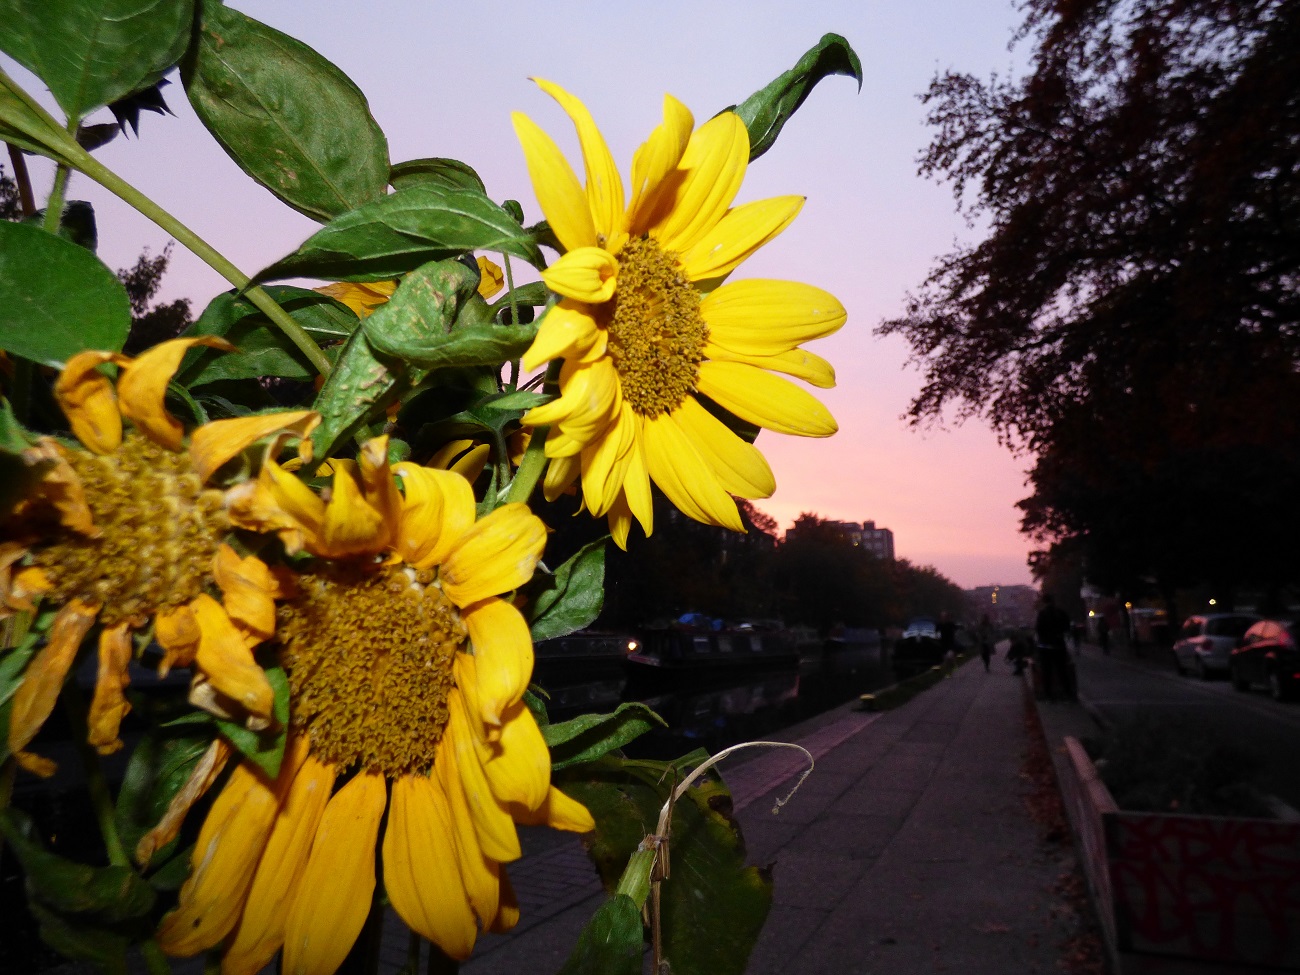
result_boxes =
[0,0,194,122]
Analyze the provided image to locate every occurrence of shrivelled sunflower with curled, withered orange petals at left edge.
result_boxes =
[0,337,317,775]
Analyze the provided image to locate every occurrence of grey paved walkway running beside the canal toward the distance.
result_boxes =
[462,658,1086,975]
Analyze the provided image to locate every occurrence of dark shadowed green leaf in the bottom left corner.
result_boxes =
[0,809,155,923]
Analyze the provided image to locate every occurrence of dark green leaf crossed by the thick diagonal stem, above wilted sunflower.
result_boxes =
[177,285,359,389]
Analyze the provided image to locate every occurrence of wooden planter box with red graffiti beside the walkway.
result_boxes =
[1061,737,1300,975]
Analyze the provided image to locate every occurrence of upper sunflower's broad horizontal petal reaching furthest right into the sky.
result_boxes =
[699,278,848,355]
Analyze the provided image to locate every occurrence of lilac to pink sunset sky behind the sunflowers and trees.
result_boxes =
[5,0,1030,588]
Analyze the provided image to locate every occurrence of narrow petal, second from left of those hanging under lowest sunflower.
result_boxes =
[221,754,334,975]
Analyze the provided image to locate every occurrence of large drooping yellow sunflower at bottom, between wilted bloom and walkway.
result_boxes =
[159,438,593,975]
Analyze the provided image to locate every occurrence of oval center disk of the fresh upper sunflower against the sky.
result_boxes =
[608,238,709,417]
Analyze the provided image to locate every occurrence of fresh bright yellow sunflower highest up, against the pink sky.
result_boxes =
[514,81,845,546]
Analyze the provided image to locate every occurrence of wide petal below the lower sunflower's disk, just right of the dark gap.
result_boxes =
[384,775,478,961]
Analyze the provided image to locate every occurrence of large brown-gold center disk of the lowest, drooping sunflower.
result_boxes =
[277,566,467,777]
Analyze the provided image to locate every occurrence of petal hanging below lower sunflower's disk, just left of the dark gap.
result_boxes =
[282,772,387,975]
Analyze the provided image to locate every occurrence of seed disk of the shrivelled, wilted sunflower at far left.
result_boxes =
[35,433,230,625]
